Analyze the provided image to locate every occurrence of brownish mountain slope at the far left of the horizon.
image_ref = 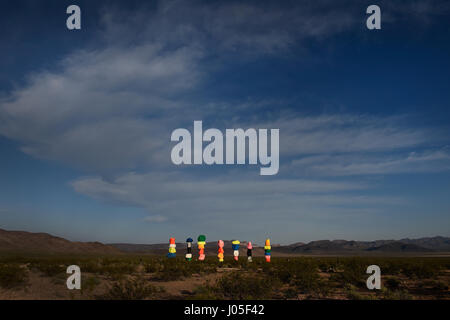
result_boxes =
[0,229,121,254]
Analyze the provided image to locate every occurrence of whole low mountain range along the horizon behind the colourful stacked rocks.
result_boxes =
[0,229,450,256]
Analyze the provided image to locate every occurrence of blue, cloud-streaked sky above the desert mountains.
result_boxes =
[0,0,450,244]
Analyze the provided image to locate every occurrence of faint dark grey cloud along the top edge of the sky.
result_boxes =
[97,0,359,55]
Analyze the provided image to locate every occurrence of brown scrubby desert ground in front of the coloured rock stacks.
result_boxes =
[0,254,450,300]
